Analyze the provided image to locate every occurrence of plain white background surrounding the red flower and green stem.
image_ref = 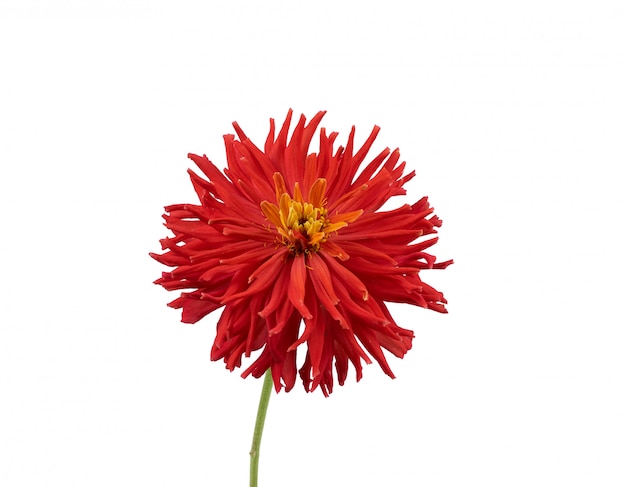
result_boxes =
[0,0,626,487]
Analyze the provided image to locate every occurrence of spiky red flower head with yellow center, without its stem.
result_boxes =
[151,110,452,395]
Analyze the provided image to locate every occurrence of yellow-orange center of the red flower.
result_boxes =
[261,173,363,255]
